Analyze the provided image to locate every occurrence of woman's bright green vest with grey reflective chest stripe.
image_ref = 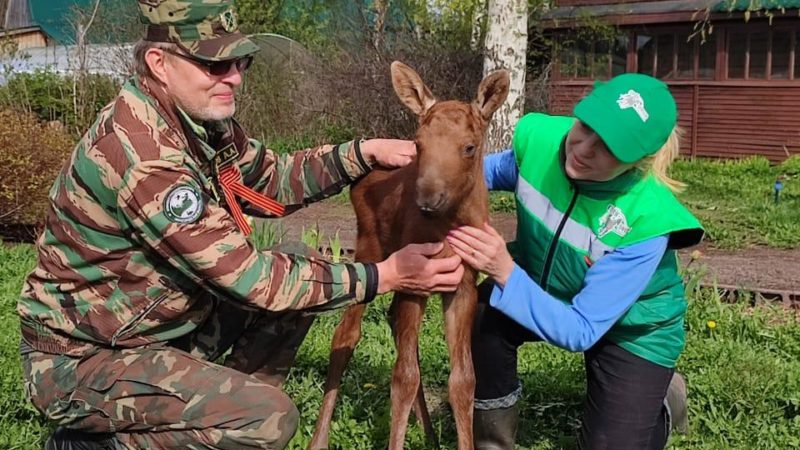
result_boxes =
[511,114,703,367]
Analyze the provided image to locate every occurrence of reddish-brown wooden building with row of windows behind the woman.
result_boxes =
[545,0,800,162]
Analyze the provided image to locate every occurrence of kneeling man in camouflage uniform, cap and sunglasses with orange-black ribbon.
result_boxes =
[18,0,463,449]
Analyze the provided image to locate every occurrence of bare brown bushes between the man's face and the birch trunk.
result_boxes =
[231,36,483,147]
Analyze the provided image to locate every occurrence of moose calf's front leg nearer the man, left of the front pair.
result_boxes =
[389,294,426,450]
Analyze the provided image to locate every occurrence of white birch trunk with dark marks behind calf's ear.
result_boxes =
[483,0,528,152]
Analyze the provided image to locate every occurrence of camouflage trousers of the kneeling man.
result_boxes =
[22,292,314,449]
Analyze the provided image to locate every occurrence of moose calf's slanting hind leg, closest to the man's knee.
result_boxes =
[308,304,367,450]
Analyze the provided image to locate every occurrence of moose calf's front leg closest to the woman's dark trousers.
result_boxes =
[444,284,477,450]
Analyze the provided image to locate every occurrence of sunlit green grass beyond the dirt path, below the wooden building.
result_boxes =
[672,156,800,249]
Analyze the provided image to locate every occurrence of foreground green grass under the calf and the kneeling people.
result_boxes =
[0,245,800,449]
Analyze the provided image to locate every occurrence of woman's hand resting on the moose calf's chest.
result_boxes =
[447,223,514,287]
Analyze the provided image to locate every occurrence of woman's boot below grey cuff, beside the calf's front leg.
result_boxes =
[472,404,519,450]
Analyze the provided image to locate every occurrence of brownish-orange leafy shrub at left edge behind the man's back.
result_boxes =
[0,110,74,225]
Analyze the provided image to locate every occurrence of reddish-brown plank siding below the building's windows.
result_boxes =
[549,81,800,162]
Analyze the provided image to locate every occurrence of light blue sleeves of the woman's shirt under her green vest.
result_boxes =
[484,150,668,351]
